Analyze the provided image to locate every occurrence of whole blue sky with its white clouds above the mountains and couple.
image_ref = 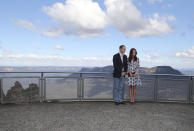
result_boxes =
[0,0,194,68]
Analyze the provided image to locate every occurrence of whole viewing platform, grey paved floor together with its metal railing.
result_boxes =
[0,72,194,131]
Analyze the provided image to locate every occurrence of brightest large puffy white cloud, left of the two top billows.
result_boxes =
[43,0,107,38]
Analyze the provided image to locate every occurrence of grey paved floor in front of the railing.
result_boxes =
[0,102,194,131]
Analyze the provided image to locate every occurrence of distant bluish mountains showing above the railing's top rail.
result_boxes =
[0,66,185,75]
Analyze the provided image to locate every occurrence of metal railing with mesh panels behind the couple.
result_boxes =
[0,72,194,104]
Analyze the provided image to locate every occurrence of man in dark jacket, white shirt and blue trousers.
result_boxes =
[113,45,127,105]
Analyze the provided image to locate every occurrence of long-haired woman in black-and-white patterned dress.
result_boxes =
[128,48,141,103]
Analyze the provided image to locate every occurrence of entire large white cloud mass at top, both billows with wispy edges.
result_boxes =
[16,0,176,38]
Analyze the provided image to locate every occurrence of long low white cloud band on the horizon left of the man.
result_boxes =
[0,50,112,66]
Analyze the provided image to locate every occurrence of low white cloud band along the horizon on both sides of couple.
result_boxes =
[0,46,194,68]
